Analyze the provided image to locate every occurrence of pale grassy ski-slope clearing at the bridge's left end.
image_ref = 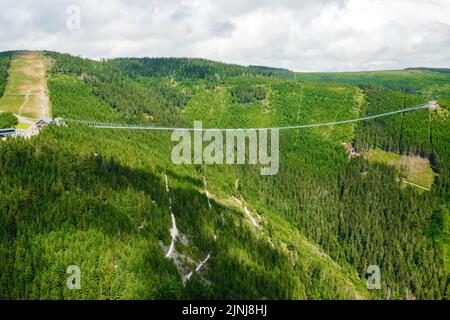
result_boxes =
[0,52,51,124]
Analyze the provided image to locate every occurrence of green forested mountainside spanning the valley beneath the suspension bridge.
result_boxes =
[0,52,450,299]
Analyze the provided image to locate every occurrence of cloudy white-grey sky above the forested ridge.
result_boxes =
[0,0,450,71]
